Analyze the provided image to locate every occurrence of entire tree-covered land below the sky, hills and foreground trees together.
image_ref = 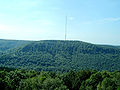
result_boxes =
[0,40,120,90]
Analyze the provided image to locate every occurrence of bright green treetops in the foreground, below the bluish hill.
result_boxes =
[0,68,120,90]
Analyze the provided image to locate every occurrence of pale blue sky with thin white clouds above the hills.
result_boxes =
[0,0,120,45]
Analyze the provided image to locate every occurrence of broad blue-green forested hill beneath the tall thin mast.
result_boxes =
[0,40,120,71]
